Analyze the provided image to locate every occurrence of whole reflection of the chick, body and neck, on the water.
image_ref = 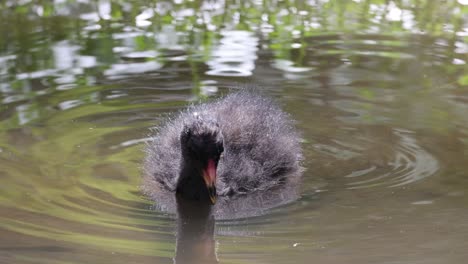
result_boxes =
[146,184,299,264]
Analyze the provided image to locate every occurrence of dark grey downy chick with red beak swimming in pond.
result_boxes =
[143,91,302,204]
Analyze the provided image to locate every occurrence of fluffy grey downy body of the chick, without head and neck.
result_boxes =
[144,91,302,196]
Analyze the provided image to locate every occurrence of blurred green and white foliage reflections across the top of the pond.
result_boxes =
[0,0,468,129]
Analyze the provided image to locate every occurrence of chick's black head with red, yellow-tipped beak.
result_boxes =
[180,118,224,204]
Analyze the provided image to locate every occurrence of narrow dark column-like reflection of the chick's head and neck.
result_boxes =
[174,197,218,264]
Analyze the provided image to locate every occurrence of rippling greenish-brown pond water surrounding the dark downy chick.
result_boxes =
[0,0,468,264]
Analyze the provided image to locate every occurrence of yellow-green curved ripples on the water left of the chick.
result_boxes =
[0,82,190,257]
